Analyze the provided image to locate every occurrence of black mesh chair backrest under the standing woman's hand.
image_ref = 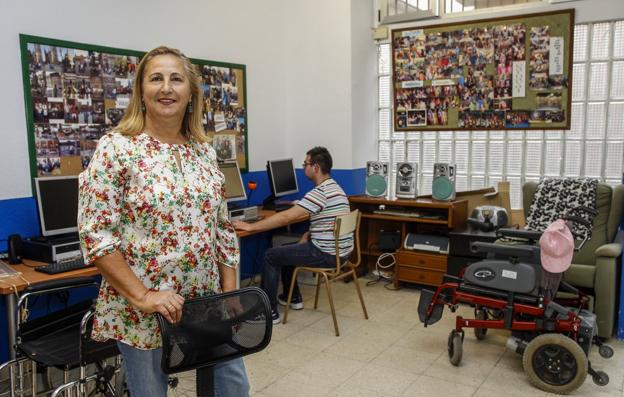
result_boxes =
[157,287,273,374]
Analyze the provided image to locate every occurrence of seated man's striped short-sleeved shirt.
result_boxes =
[297,178,353,257]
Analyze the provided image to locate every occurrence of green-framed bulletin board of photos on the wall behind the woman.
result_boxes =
[20,35,249,177]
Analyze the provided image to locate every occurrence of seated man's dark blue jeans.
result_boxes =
[260,241,336,311]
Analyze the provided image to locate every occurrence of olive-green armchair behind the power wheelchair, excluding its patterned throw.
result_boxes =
[522,181,624,338]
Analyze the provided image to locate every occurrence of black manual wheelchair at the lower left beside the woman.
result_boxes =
[0,277,124,397]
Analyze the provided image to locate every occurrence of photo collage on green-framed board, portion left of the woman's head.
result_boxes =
[27,43,139,176]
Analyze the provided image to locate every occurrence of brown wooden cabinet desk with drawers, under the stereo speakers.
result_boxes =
[349,196,467,285]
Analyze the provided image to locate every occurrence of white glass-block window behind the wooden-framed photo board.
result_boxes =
[378,21,624,208]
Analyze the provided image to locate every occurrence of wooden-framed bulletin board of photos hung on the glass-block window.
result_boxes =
[392,9,574,131]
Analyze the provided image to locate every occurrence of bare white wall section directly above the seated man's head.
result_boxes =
[283,0,357,168]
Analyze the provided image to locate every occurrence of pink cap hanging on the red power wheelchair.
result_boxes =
[540,219,574,273]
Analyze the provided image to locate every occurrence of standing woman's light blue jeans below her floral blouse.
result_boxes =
[117,342,249,397]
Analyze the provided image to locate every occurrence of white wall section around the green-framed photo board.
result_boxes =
[0,0,285,198]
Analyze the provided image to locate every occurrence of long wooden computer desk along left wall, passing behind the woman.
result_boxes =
[0,210,309,358]
